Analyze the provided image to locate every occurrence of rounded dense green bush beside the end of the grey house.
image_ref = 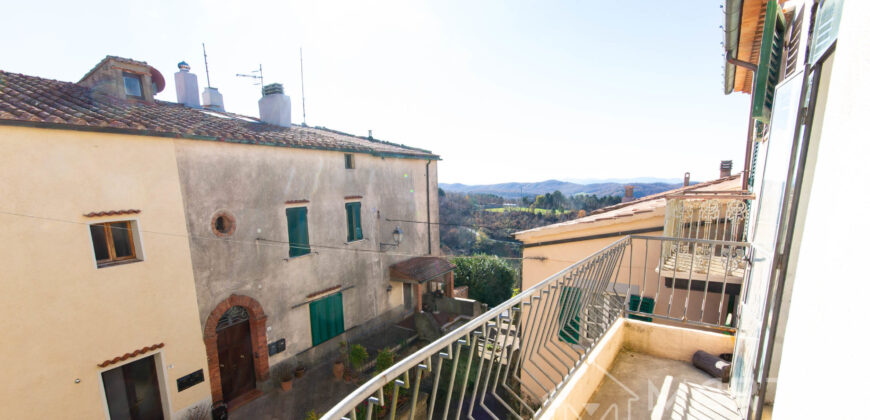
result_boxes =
[452,255,517,307]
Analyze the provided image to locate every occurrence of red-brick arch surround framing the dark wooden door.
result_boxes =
[203,294,269,402]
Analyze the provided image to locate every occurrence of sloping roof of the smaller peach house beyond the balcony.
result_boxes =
[514,174,742,237]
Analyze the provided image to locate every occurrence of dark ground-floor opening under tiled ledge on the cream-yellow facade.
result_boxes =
[102,356,163,420]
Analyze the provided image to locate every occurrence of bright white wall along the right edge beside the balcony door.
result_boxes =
[773,0,870,419]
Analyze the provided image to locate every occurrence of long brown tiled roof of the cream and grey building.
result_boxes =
[0,69,438,159]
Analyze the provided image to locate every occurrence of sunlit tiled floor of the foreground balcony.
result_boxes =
[581,350,740,420]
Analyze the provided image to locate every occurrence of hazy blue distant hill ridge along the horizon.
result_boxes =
[438,179,694,198]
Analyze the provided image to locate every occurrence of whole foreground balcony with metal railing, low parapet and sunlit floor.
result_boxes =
[323,235,749,420]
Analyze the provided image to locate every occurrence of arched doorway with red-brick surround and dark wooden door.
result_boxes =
[204,295,269,403]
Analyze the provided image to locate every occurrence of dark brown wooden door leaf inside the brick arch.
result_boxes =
[218,321,256,402]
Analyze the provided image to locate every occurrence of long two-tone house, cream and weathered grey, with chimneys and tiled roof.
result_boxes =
[0,57,439,418]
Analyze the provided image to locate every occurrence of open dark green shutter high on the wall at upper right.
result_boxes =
[752,0,785,124]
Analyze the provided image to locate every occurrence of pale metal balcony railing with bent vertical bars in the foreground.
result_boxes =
[323,236,748,420]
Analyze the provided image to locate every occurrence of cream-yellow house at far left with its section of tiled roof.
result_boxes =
[0,60,210,419]
